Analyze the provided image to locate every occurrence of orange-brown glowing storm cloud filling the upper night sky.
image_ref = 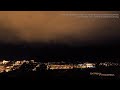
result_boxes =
[0,11,120,44]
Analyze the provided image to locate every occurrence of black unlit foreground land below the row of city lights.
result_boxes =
[0,70,120,81]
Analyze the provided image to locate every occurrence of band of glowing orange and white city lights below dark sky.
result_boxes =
[0,60,119,73]
